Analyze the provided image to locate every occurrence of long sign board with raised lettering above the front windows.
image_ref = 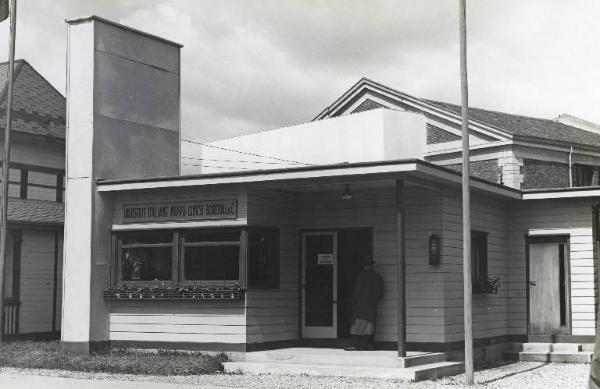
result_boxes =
[122,199,237,223]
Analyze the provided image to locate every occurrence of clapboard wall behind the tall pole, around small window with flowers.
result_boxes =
[441,191,509,342]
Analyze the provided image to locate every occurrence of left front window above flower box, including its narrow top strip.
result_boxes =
[118,233,175,281]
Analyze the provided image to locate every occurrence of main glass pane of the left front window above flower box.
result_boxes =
[121,246,173,281]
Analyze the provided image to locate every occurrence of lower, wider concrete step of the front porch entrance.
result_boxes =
[224,362,464,381]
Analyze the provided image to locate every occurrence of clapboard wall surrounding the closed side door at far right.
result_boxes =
[509,199,598,335]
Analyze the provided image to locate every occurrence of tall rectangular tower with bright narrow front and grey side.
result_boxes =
[62,16,182,352]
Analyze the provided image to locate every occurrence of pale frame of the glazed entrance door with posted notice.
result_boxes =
[298,229,338,339]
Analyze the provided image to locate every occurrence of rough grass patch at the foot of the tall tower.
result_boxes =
[0,341,228,375]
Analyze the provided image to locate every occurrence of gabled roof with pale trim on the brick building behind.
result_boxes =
[315,78,600,147]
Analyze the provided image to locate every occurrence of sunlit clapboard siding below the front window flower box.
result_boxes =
[109,301,246,343]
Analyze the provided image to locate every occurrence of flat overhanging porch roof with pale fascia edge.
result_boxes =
[97,159,521,199]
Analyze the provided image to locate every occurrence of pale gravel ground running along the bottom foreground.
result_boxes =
[0,362,590,389]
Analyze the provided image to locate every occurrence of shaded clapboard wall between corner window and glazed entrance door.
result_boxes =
[246,190,299,343]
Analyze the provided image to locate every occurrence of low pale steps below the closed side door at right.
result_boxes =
[504,343,594,363]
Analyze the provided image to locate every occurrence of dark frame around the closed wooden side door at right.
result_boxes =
[525,234,573,336]
